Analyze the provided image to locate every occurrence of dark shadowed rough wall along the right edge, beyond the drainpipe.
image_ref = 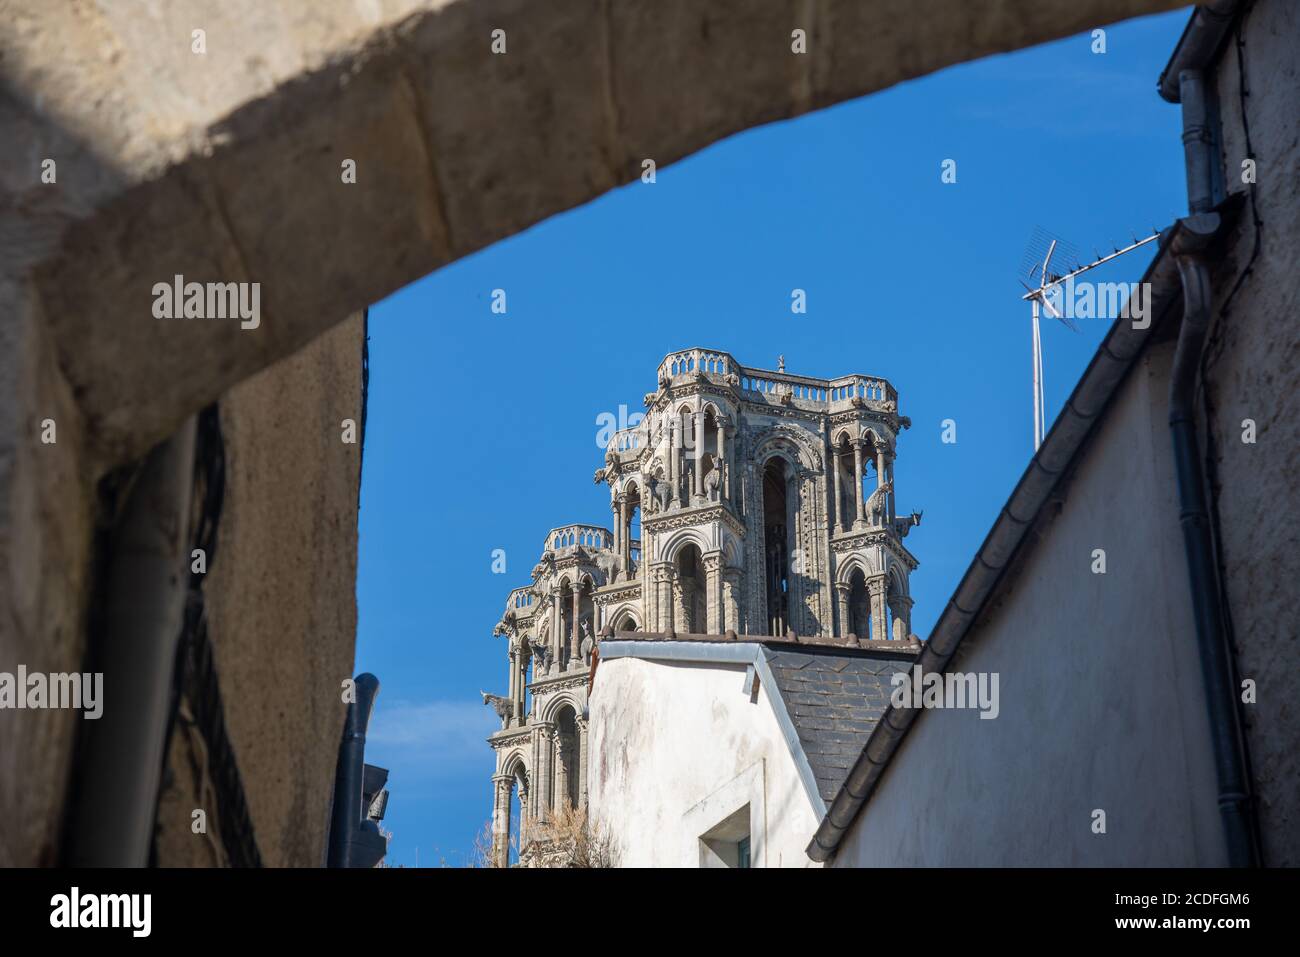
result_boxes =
[1201,0,1300,867]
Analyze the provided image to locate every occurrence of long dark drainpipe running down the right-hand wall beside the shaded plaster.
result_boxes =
[1169,70,1258,867]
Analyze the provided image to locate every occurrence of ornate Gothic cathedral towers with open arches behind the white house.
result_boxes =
[485,348,920,865]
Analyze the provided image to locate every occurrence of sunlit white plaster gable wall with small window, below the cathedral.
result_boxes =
[588,658,822,867]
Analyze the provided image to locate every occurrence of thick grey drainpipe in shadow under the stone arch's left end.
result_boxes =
[65,417,195,867]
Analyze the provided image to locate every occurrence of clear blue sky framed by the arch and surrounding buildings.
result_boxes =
[356,12,1187,867]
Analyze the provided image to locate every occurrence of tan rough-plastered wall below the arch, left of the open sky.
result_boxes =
[159,315,365,867]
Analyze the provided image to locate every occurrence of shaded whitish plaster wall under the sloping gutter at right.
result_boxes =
[835,343,1226,867]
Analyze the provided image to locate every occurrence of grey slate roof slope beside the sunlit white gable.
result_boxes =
[763,645,915,806]
